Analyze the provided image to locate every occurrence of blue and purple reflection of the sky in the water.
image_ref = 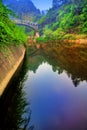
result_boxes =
[24,62,87,130]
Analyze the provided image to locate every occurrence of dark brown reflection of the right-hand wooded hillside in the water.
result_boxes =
[43,45,87,86]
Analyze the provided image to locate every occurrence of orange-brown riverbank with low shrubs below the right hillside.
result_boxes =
[34,34,87,45]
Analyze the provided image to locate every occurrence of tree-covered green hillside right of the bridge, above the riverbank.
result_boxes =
[39,0,87,40]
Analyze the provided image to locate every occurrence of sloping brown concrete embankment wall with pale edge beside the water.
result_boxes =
[0,46,25,96]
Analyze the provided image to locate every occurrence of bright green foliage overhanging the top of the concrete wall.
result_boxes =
[0,1,26,46]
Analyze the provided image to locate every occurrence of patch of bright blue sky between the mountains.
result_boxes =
[31,0,52,10]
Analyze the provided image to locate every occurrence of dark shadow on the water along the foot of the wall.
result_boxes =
[0,51,33,130]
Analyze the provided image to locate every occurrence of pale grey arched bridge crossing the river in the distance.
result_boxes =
[12,19,38,31]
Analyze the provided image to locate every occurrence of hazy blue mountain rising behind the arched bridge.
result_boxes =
[3,0,41,20]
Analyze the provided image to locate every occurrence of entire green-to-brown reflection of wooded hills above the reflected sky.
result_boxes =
[28,46,87,87]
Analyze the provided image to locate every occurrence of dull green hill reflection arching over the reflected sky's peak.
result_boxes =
[28,47,63,74]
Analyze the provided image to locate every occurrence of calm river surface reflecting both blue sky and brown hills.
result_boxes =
[2,45,87,130]
